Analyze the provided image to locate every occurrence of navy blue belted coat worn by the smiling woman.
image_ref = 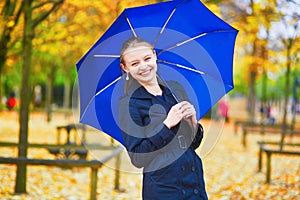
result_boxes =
[119,81,207,200]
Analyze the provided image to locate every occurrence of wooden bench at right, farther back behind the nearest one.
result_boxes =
[241,124,300,147]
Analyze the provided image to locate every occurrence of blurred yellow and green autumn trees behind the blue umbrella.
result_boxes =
[0,0,300,124]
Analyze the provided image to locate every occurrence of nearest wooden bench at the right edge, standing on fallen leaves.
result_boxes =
[258,141,300,183]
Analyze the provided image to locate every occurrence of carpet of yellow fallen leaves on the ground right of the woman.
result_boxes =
[199,118,300,200]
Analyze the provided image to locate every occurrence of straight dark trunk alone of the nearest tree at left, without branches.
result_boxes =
[15,0,34,193]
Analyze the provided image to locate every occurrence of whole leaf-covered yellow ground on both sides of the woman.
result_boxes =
[0,112,300,200]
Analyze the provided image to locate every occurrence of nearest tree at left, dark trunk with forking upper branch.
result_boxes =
[15,0,63,193]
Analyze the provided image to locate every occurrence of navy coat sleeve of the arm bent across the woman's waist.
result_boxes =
[119,96,175,168]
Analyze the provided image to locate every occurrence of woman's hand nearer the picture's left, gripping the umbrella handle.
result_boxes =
[163,103,183,129]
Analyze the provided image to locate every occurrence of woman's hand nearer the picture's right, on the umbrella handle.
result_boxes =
[180,101,198,128]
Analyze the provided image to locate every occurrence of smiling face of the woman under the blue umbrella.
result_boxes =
[121,46,157,85]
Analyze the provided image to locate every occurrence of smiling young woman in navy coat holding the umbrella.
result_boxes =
[119,37,207,200]
